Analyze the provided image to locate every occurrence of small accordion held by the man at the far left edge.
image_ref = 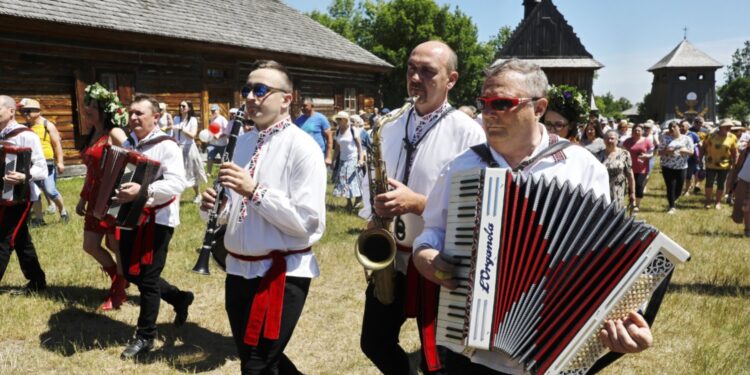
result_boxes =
[0,145,31,206]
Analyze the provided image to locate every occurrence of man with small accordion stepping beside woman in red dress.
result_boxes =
[116,96,193,359]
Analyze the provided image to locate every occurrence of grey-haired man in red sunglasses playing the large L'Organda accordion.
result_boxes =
[414,59,652,374]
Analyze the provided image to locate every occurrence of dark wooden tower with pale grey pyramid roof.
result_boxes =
[648,39,722,122]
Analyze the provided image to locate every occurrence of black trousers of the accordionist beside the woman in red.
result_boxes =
[120,224,185,339]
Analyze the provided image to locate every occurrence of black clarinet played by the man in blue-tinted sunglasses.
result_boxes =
[193,104,245,275]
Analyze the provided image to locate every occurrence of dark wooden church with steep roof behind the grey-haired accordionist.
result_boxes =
[496,0,604,99]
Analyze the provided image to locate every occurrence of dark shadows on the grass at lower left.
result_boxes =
[39,307,236,373]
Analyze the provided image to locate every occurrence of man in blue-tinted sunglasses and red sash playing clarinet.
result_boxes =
[201,61,326,374]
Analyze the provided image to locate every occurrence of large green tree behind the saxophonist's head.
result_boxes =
[310,0,494,107]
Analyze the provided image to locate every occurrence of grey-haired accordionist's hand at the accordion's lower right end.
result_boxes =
[599,311,654,353]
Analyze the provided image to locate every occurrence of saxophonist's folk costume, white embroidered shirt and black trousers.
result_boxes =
[360,102,485,373]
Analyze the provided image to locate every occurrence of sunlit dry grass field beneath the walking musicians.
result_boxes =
[0,173,750,374]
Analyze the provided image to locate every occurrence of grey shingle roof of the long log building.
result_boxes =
[0,0,392,69]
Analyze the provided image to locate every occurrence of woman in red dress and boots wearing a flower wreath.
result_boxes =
[76,83,128,311]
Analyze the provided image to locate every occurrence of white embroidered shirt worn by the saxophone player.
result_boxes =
[359,103,485,273]
